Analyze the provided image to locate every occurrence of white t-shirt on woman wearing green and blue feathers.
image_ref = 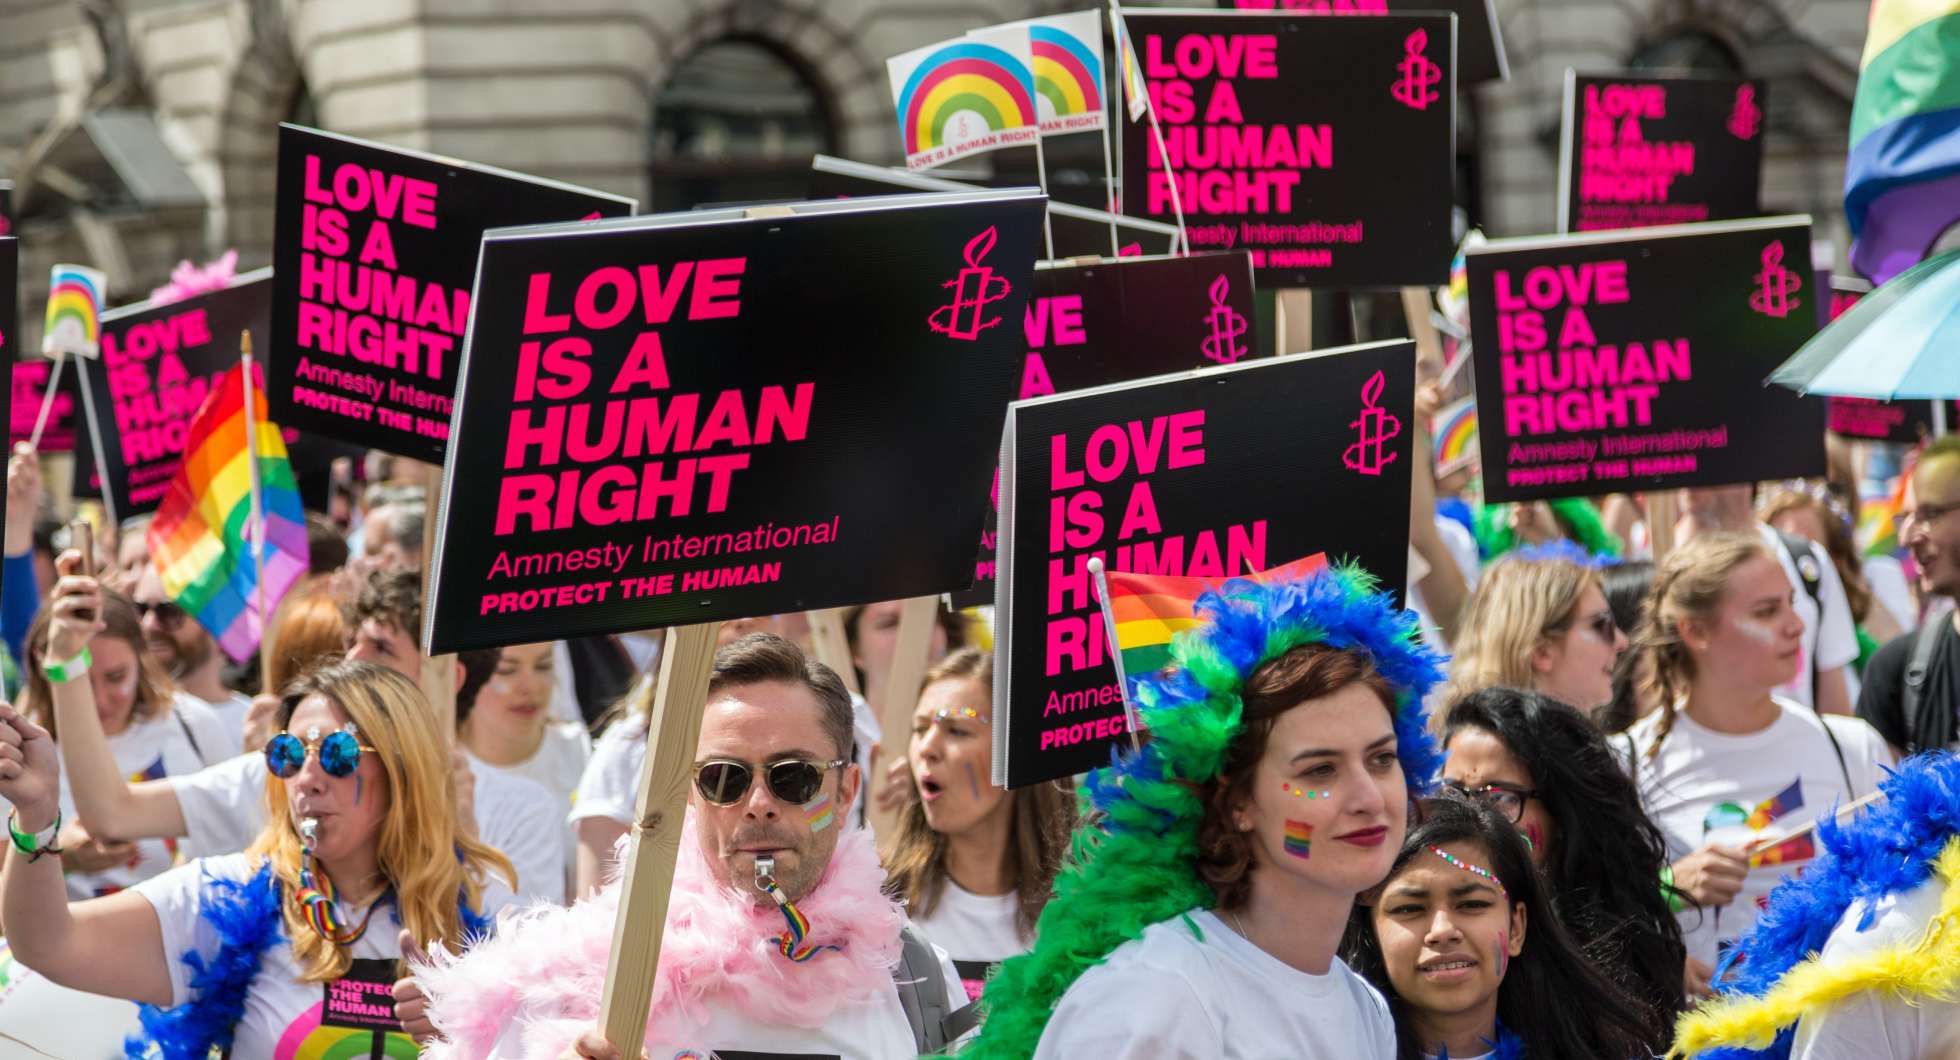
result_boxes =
[1035,909,1396,1060]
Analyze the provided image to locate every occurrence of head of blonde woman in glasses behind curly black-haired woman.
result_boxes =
[1448,551,1627,713]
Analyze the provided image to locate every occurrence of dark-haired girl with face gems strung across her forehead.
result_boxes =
[1343,797,1648,1060]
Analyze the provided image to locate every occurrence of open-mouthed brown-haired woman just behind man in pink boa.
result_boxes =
[884,649,1076,999]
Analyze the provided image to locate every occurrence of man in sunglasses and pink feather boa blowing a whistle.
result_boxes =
[396,633,966,1060]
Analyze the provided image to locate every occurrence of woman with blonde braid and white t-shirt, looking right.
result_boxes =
[1625,533,1891,995]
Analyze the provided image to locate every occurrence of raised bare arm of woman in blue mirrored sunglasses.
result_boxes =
[0,705,171,1005]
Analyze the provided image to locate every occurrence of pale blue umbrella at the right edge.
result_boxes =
[1766,251,1960,408]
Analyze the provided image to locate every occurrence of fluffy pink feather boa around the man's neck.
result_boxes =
[416,811,906,1060]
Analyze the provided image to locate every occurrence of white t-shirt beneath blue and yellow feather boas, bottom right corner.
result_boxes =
[1789,876,1960,1060]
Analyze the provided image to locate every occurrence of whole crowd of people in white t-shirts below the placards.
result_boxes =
[0,415,1960,1060]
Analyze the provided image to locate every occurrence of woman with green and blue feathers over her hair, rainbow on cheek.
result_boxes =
[960,568,1439,1060]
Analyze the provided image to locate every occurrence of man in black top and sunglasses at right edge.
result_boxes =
[1858,435,1960,754]
